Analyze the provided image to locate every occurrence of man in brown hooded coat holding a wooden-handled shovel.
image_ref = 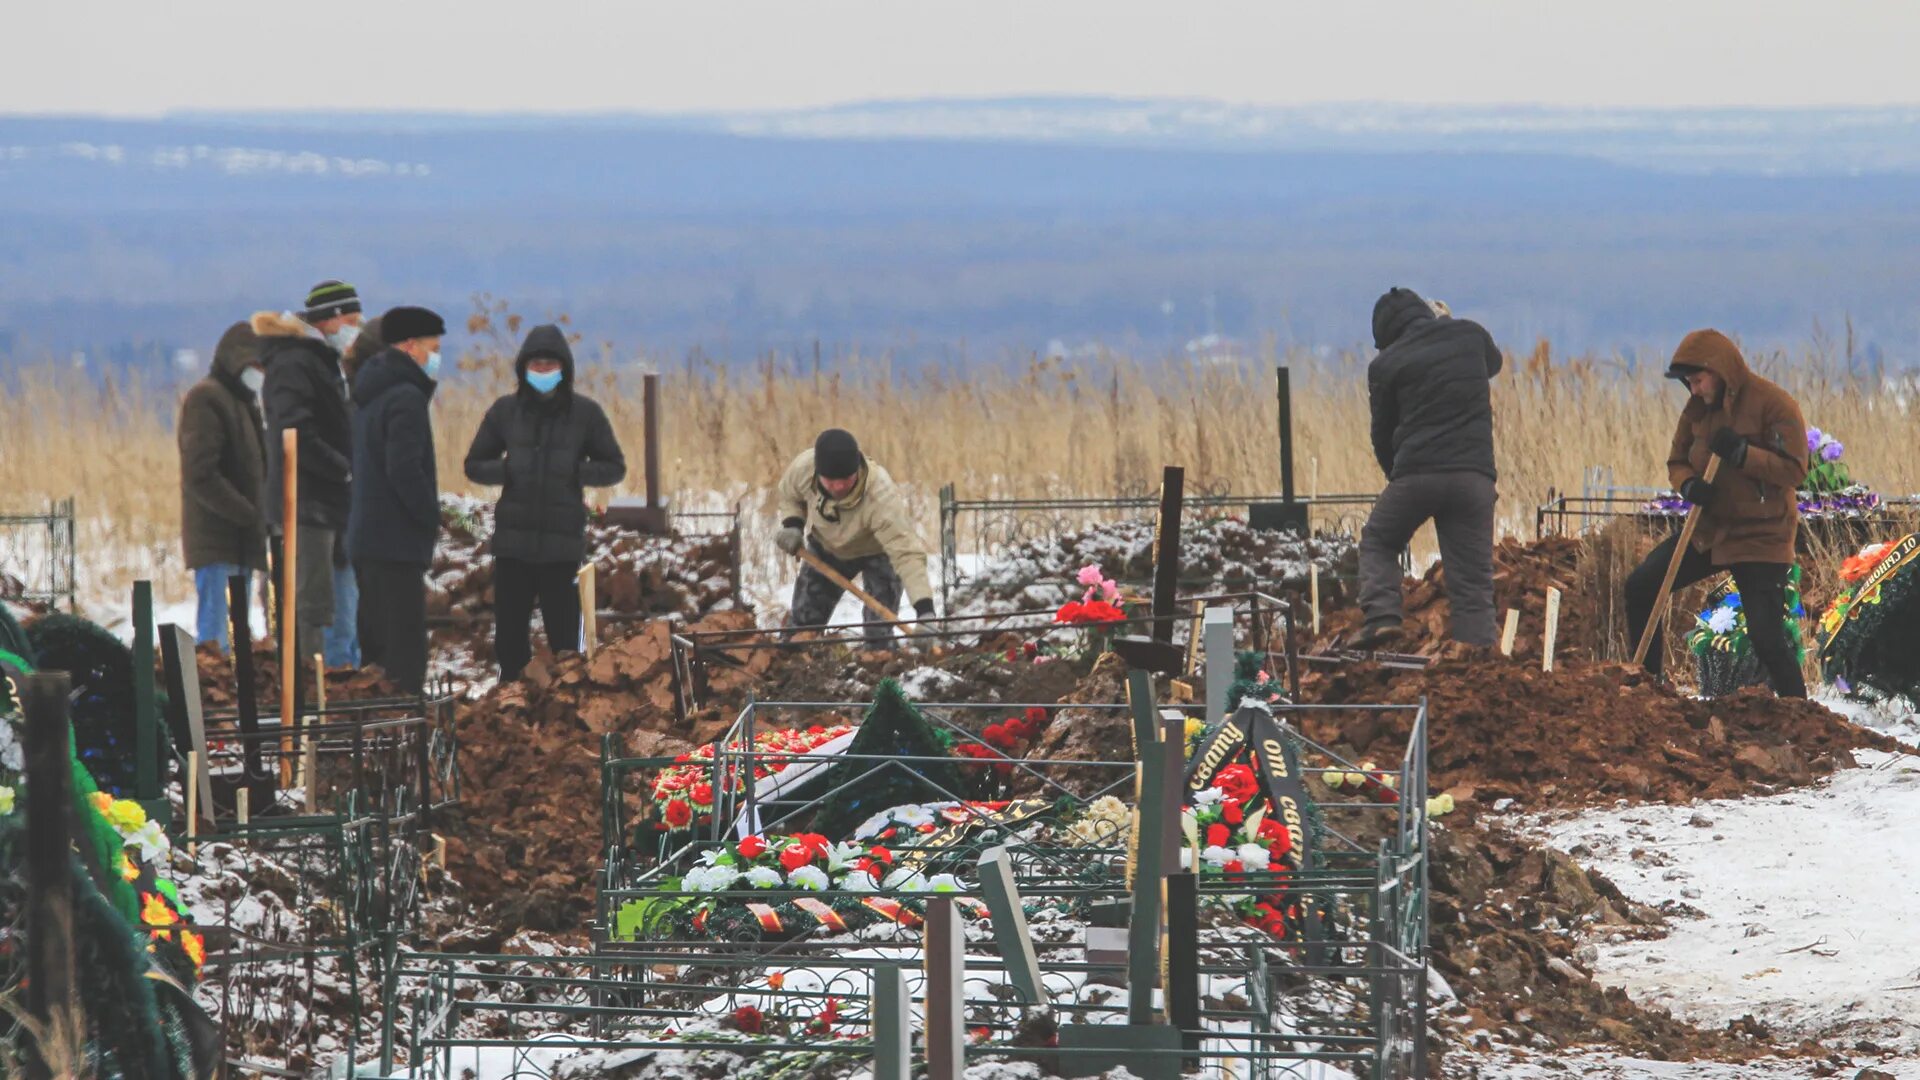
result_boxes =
[1626,331,1807,698]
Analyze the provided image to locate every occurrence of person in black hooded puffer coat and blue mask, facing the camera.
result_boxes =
[467,325,626,680]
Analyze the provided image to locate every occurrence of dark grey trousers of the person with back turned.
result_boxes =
[1359,473,1498,646]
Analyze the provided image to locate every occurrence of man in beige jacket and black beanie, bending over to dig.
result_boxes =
[774,429,933,646]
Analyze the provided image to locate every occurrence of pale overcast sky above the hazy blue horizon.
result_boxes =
[15,0,1920,115]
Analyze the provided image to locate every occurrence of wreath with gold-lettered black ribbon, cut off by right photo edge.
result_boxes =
[1818,534,1920,700]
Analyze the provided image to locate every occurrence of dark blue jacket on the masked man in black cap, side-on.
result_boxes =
[348,348,440,567]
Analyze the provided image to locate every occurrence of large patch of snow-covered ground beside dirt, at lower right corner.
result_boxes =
[1528,734,1920,1060]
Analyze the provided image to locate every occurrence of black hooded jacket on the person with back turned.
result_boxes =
[1367,288,1501,480]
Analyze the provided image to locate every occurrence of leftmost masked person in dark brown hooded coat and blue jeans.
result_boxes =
[177,323,267,651]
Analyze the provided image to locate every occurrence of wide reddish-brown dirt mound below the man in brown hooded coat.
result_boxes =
[1304,659,1905,807]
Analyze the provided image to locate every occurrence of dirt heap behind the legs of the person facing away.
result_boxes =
[1319,536,1596,661]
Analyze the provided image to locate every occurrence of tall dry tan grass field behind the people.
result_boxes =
[0,303,1920,614]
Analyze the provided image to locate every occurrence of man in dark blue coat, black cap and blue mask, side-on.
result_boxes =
[348,307,447,694]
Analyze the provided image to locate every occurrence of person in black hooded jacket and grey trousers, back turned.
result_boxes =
[1354,288,1501,650]
